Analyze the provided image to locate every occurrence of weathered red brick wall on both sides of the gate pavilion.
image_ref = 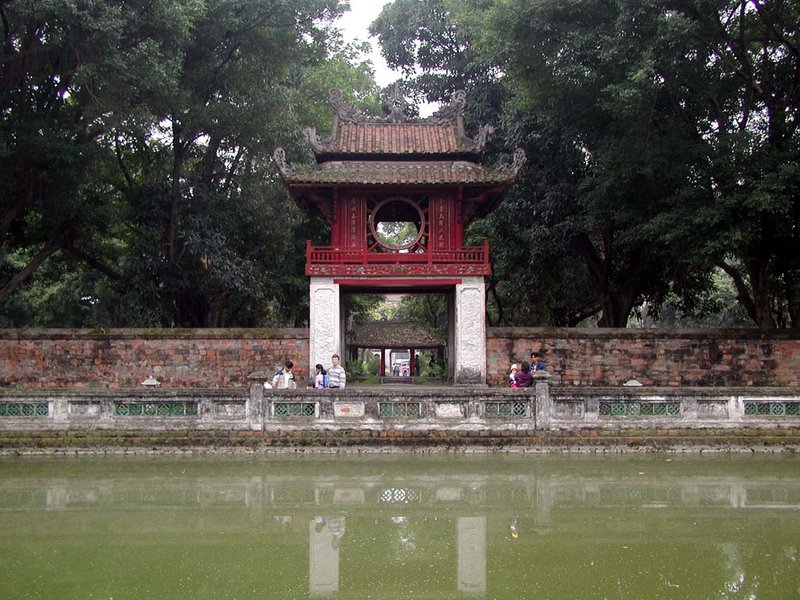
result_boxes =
[6,328,800,388]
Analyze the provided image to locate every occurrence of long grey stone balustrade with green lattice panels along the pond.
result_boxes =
[0,376,800,430]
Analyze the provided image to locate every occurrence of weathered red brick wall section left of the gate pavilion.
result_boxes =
[0,329,308,388]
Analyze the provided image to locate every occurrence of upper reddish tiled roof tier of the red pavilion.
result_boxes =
[324,122,468,155]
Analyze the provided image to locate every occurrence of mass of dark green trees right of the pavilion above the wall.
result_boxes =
[373,0,800,328]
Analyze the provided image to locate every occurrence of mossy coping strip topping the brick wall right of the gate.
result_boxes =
[486,327,800,341]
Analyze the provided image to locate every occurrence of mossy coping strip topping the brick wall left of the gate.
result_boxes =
[0,327,308,340]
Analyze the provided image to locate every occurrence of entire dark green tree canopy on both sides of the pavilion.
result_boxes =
[0,0,800,329]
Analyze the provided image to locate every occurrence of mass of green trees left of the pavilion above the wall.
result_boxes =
[0,0,377,326]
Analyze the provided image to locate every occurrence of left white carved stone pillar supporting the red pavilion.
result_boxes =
[308,277,345,375]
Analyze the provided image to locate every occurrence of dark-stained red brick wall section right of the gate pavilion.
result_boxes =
[486,328,800,387]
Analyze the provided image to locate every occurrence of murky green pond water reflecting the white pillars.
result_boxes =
[0,455,800,600]
